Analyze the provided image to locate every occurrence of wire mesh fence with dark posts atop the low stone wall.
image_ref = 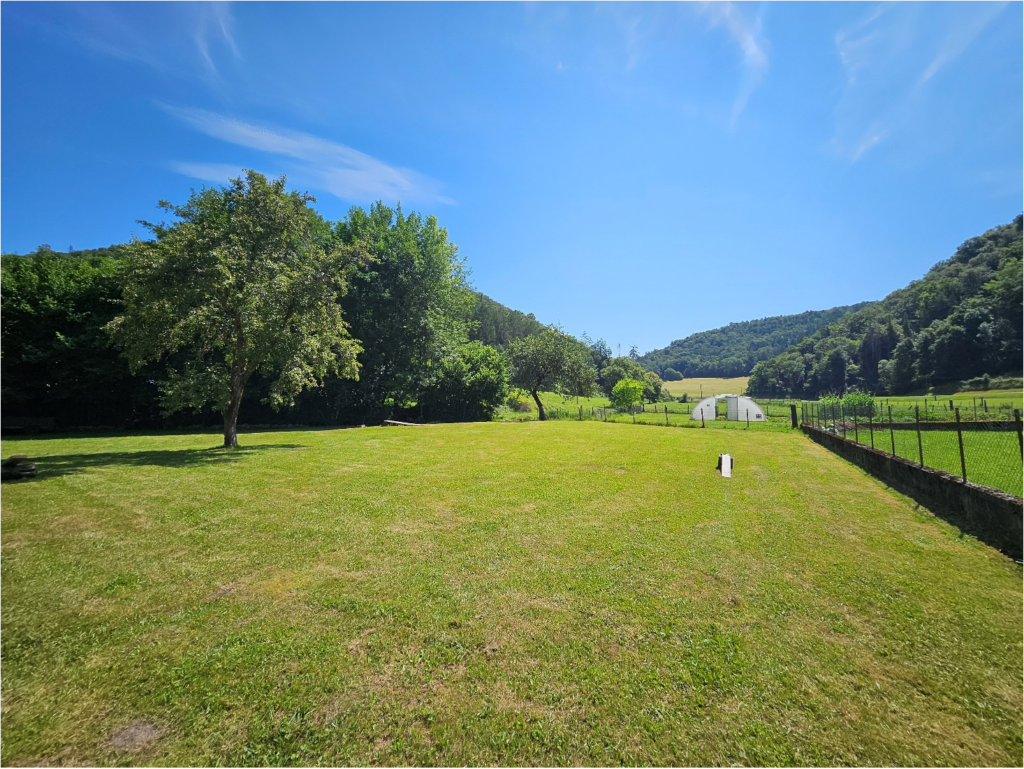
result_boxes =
[801,402,1024,498]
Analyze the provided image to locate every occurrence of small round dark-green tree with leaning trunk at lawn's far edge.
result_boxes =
[509,328,597,420]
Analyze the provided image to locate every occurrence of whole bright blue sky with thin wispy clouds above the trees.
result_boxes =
[0,0,1024,351]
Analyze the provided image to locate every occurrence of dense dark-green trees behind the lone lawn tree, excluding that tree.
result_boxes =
[0,204,547,427]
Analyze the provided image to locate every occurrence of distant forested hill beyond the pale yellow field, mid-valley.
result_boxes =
[640,302,867,380]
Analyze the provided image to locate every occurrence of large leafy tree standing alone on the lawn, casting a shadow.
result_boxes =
[110,171,359,447]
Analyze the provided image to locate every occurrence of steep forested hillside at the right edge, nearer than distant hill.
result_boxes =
[749,214,1024,397]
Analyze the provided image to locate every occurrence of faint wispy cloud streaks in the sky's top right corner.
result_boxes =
[833,0,1010,162]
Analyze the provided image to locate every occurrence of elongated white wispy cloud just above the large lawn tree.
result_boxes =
[159,104,455,204]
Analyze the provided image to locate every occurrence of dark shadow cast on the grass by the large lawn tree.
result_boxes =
[9,443,306,482]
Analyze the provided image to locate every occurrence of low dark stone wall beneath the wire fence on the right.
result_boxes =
[803,424,1024,559]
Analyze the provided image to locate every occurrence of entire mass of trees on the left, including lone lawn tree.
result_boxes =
[0,172,593,445]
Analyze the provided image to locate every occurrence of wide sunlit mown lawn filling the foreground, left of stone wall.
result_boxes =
[0,420,1024,765]
